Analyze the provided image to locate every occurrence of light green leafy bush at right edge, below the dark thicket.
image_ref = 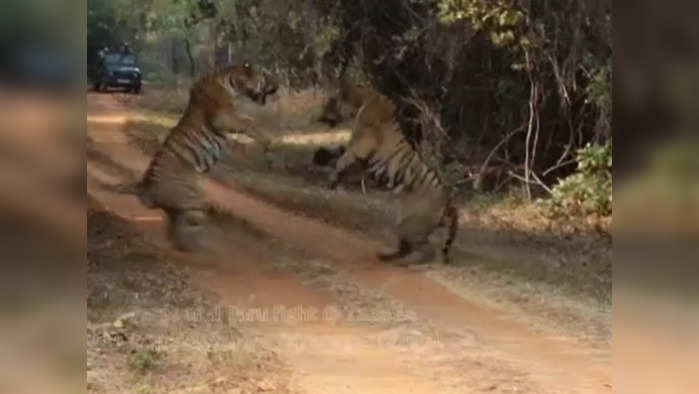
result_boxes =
[542,143,612,217]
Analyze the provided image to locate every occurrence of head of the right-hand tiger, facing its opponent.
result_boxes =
[318,80,374,127]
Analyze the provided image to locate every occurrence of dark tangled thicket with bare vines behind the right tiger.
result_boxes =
[315,0,612,184]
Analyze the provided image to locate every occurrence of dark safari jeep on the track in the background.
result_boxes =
[93,52,141,93]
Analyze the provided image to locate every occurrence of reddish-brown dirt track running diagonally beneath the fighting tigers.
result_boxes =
[87,94,611,393]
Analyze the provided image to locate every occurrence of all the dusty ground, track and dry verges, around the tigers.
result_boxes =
[87,94,611,393]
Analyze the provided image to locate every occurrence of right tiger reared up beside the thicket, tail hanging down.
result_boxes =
[313,82,458,263]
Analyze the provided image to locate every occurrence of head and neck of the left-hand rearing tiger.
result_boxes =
[190,62,279,117]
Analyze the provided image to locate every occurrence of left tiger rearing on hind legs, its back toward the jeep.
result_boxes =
[136,62,279,250]
